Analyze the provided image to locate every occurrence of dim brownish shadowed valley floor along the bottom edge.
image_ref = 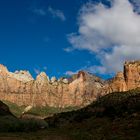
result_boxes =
[0,114,140,140]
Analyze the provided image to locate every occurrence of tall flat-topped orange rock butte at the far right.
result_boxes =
[108,61,140,93]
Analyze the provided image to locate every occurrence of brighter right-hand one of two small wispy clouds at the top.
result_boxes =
[48,7,66,21]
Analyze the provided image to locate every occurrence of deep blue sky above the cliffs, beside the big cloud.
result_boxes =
[0,0,139,77]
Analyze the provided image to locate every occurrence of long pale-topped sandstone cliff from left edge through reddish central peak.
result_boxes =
[0,65,104,107]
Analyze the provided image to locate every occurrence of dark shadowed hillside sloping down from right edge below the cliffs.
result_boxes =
[45,89,140,140]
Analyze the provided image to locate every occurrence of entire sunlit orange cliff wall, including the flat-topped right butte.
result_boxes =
[0,61,140,107]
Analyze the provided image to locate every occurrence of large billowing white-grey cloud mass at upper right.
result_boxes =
[68,0,140,74]
